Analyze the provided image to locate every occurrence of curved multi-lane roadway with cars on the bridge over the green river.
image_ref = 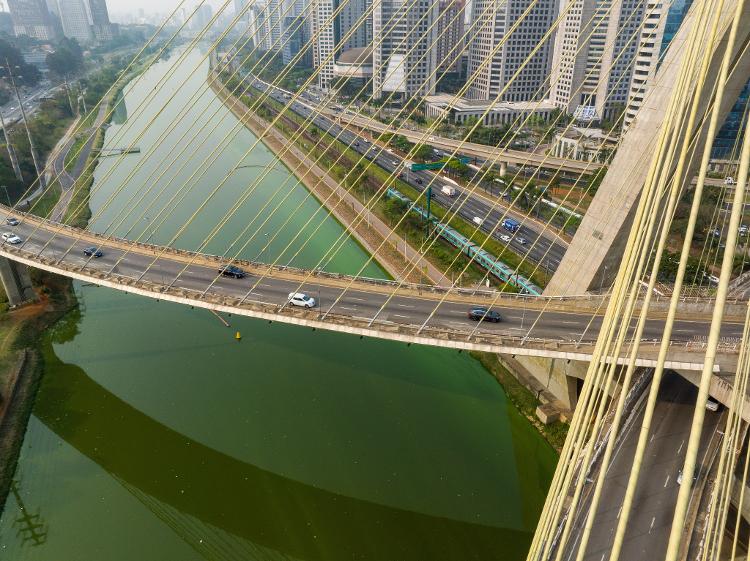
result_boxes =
[0,207,742,350]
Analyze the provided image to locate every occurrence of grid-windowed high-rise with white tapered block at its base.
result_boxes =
[372,0,439,99]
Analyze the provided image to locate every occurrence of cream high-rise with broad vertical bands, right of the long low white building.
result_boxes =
[550,0,644,121]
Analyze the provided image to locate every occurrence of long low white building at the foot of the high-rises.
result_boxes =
[425,94,557,127]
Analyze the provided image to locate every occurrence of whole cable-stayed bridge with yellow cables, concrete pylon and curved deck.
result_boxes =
[0,0,750,561]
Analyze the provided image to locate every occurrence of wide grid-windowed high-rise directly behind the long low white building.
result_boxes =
[467,0,560,101]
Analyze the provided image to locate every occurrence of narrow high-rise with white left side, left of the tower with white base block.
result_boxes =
[310,0,372,89]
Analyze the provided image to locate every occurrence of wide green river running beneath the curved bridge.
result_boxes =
[0,46,556,561]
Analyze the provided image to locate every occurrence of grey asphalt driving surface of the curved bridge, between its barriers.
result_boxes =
[0,214,742,342]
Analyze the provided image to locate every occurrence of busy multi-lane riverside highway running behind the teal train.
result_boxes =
[244,70,567,274]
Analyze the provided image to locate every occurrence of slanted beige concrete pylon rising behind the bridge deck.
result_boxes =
[544,0,750,296]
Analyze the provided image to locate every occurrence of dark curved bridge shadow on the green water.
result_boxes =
[35,336,531,560]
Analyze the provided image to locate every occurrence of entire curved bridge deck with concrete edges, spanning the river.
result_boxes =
[0,205,744,370]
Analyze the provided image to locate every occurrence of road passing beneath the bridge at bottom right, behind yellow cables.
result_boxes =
[564,372,722,561]
